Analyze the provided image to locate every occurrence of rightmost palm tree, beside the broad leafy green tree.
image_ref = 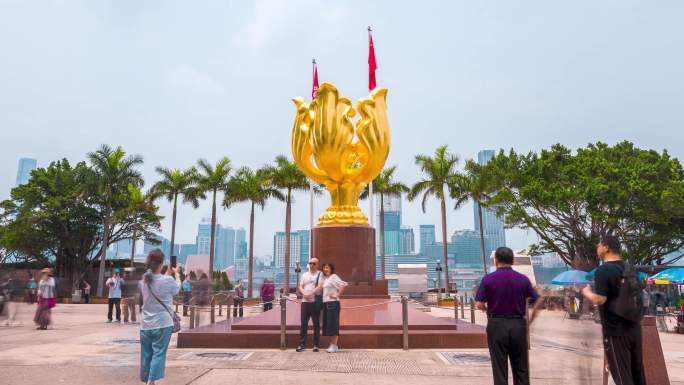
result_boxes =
[450,160,492,274]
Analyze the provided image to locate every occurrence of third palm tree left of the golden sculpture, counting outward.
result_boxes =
[197,157,232,277]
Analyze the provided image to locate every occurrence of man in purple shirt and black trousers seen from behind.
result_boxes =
[475,247,541,385]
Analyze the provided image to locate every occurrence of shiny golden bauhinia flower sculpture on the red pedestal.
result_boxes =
[292,83,390,226]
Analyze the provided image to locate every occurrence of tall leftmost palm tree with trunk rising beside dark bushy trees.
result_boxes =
[87,144,144,296]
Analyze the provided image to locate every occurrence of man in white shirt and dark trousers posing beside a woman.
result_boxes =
[296,258,323,352]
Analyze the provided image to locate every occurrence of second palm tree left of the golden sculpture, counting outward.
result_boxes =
[223,167,285,298]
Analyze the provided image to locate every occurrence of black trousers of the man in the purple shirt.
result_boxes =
[487,317,530,385]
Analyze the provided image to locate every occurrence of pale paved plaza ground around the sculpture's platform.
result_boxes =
[0,305,684,385]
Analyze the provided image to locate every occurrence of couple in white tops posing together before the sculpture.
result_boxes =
[296,258,347,353]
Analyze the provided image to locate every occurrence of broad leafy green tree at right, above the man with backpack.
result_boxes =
[482,142,684,271]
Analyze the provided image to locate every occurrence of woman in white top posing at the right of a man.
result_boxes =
[323,263,347,353]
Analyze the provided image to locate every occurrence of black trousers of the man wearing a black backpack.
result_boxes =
[603,333,646,385]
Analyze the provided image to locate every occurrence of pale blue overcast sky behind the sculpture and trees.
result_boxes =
[0,0,684,255]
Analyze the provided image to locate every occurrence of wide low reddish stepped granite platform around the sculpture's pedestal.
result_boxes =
[177,298,487,349]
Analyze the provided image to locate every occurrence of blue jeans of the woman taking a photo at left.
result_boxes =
[140,326,173,382]
